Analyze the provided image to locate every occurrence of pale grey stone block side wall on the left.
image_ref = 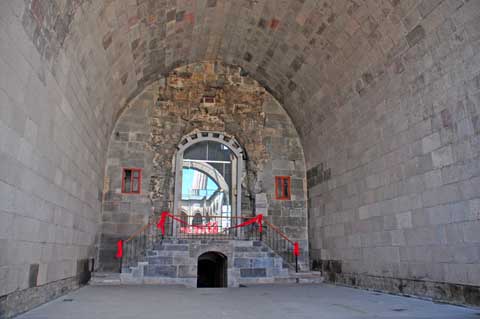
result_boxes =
[0,1,100,318]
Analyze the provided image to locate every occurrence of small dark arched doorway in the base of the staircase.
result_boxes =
[197,251,228,288]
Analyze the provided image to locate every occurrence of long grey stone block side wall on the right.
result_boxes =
[300,1,480,304]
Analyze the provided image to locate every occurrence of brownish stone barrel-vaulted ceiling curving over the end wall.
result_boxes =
[22,0,475,165]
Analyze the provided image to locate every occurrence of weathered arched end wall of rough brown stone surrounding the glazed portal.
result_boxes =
[100,63,308,270]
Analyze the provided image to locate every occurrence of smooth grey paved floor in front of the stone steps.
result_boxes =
[19,284,480,319]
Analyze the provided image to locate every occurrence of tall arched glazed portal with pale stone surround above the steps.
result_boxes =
[174,132,243,228]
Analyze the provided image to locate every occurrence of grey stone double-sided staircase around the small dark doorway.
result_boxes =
[91,239,323,287]
